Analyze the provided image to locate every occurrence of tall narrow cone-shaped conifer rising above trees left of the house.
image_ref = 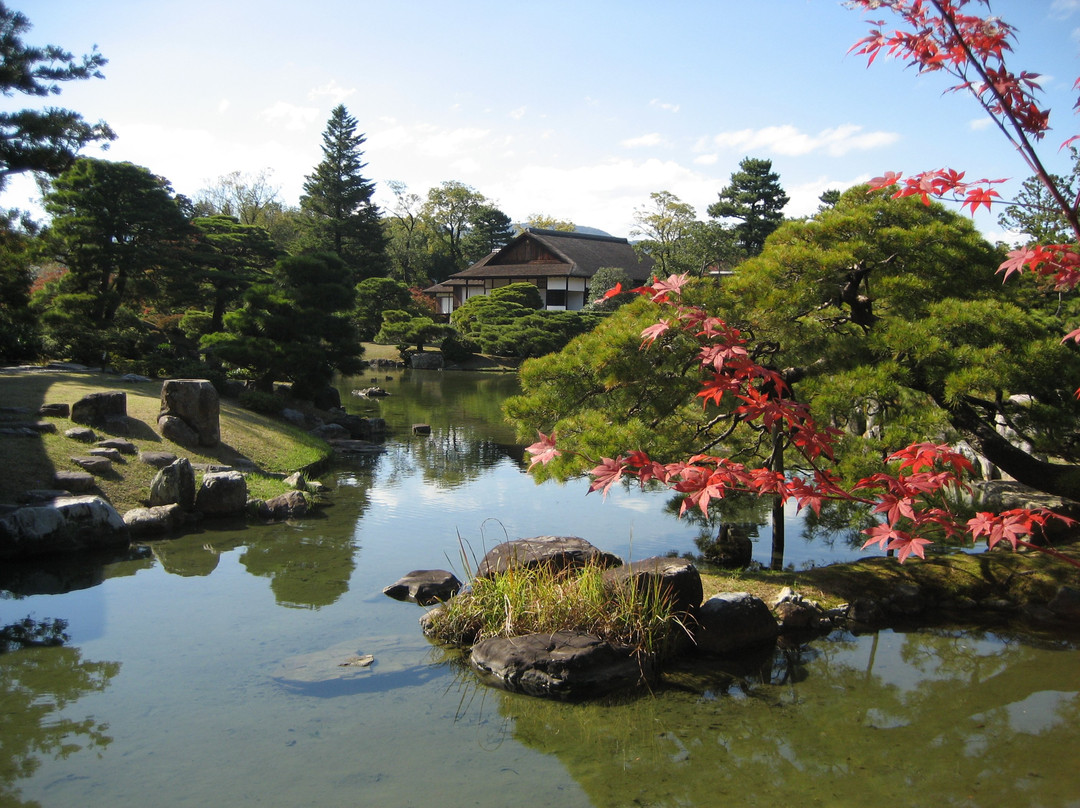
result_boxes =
[300,105,388,279]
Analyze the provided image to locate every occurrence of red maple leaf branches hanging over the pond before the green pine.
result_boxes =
[526,275,1080,566]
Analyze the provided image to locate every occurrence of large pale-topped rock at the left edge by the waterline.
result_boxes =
[0,496,127,558]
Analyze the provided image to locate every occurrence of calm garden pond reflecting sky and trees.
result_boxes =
[0,372,1080,808]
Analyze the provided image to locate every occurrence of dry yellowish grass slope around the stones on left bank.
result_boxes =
[0,369,328,512]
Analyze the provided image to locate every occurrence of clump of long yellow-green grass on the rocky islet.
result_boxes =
[427,564,685,659]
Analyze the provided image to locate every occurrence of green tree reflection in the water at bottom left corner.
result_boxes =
[0,620,120,806]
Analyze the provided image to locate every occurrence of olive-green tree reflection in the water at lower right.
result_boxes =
[479,633,1080,807]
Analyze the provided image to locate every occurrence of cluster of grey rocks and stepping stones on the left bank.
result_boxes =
[0,379,324,558]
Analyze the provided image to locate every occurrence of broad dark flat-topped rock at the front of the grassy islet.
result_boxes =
[469,631,643,701]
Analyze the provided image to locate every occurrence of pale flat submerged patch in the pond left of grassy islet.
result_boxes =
[270,637,440,698]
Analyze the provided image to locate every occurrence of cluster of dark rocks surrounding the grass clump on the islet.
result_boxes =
[383,536,839,700]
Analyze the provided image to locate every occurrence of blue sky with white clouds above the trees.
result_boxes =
[8,0,1080,238]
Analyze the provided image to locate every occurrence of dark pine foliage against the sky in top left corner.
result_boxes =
[0,3,116,190]
